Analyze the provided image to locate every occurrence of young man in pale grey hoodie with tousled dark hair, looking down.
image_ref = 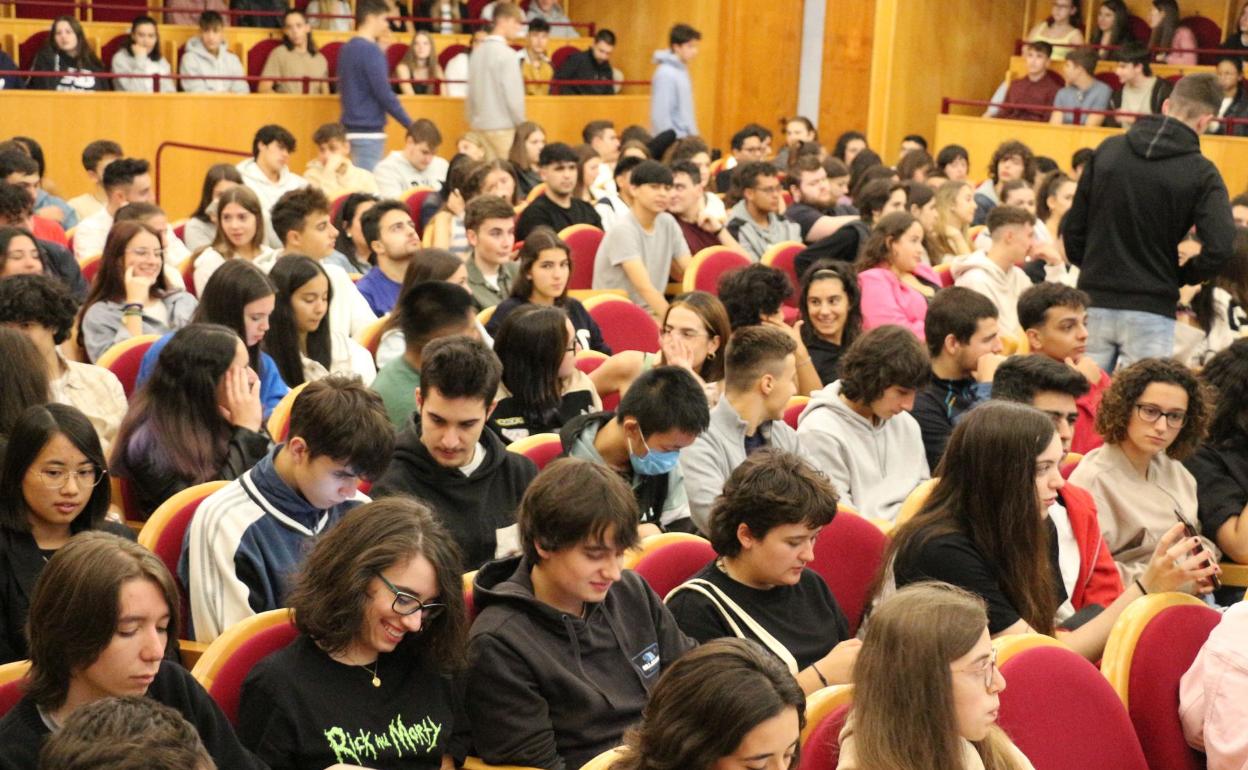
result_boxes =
[797,326,931,522]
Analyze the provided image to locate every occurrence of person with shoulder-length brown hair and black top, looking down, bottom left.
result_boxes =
[0,532,265,770]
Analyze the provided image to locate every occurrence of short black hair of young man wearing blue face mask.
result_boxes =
[615,366,710,437]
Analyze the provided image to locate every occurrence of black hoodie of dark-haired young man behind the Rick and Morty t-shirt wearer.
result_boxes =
[372,414,538,569]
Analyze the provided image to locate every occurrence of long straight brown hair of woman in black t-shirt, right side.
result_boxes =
[884,401,1057,634]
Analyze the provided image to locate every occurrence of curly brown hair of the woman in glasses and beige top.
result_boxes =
[1096,358,1213,461]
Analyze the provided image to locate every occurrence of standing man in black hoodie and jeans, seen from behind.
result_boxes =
[1063,74,1236,372]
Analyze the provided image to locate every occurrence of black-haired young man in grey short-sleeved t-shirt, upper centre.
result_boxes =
[591,159,689,318]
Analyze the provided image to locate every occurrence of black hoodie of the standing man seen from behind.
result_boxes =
[1063,115,1236,318]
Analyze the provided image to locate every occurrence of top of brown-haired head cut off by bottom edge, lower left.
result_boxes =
[39,695,216,770]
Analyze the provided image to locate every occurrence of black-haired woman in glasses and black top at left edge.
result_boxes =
[0,404,135,663]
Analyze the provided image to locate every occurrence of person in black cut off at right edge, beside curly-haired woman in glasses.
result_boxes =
[1184,339,1248,564]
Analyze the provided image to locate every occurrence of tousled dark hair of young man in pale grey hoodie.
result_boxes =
[841,324,931,404]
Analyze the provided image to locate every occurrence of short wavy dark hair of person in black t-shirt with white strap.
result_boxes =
[708,446,840,557]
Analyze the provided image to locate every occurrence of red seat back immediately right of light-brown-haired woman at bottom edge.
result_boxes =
[998,646,1148,770]
